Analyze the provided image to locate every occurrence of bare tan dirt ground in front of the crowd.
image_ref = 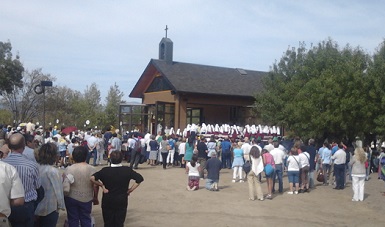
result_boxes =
[57,160,385,227]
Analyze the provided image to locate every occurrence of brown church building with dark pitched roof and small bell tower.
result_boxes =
[127,36,267,134]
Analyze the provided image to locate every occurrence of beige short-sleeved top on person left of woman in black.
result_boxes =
[66,163,96,203]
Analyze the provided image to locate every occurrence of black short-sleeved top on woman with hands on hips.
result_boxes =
[94,166,144,208]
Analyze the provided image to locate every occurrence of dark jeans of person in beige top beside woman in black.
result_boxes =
[64,196,92,227]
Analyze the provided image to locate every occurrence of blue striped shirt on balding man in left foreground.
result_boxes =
[3,152,41,202]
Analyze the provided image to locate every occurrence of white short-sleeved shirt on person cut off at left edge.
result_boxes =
[0,161,24,217]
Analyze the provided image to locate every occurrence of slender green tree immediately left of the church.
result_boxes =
[104,83,124,126]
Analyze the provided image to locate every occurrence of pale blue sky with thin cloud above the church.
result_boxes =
[0,0,385,101]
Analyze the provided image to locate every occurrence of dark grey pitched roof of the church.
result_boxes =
[130,59,267,97]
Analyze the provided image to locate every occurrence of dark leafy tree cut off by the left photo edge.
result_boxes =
[0,41,24,95]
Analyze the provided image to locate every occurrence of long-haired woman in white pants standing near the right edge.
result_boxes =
[349,147,367,201]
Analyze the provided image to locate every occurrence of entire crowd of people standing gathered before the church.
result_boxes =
[0,120,385,226]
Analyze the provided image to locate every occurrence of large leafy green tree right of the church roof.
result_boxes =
[256,39,373,142]
